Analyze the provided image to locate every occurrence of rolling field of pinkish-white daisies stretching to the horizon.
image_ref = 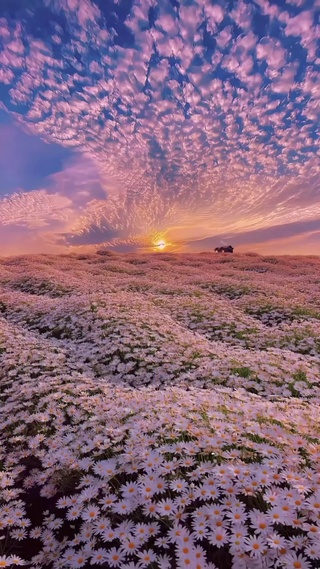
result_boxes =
[0,251,320,569]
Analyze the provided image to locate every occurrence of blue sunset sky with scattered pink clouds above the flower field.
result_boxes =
[0,0,320,256]
